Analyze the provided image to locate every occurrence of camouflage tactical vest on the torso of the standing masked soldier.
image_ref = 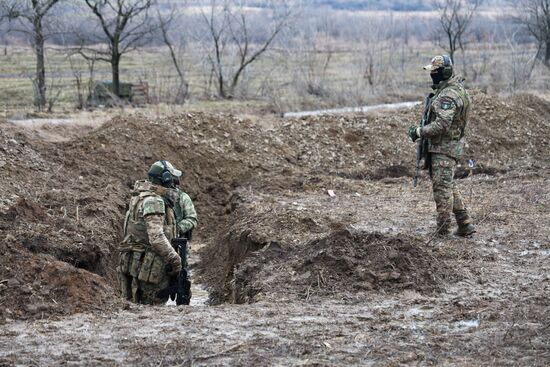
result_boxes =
[428,77,471,160]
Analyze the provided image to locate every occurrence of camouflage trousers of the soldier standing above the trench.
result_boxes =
[431,153,472,234]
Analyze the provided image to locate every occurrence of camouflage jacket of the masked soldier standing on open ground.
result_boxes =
[420,76,471,160]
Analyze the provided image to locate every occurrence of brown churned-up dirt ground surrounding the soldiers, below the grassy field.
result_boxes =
[0,93,550,366]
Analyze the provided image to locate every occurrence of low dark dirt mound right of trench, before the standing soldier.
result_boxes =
[230,230,458,303]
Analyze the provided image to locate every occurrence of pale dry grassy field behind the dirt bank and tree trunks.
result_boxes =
[0,43,550,117]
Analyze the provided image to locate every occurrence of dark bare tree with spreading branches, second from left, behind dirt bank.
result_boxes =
[81,0,157,96]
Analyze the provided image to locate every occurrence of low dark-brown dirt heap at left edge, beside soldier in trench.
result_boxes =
[0,236,123,319]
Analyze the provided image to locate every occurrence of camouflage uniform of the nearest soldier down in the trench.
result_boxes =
[117,181,181,304]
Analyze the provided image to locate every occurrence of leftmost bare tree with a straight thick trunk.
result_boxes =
[0,0,62,111]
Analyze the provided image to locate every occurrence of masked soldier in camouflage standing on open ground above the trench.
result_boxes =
[409,55,475,237]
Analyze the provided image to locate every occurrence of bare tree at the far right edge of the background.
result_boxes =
[520,0,550,68]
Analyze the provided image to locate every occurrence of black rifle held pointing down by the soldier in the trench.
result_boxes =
[157,237,191,306]
